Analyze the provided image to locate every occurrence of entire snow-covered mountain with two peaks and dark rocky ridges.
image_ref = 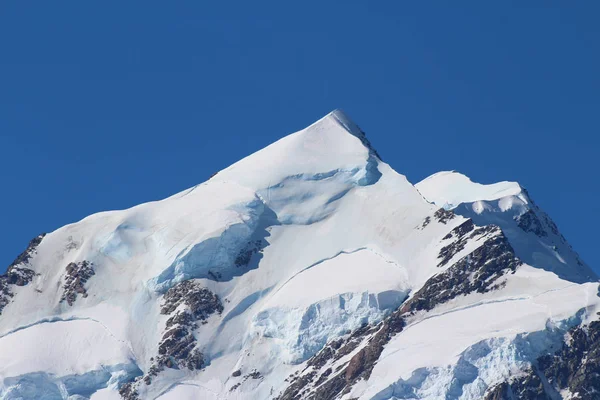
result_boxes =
[0,111,600,400]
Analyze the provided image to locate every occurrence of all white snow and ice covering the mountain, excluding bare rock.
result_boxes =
[0,110,598,400]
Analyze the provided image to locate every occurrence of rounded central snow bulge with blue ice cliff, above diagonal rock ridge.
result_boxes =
[250,249,409,364]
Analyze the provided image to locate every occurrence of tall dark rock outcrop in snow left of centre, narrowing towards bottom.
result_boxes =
[125,280,223,400]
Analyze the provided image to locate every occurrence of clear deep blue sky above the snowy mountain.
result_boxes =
[0,1,600,270]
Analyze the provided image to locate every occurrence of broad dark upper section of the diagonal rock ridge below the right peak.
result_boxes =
[402,224,521,312]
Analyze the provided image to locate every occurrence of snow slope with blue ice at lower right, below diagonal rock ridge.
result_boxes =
[350,279,600,400]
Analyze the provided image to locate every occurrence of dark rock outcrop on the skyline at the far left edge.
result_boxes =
[0,233,46,314]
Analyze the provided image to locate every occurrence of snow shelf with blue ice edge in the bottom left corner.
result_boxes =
[0,319,141,399]
